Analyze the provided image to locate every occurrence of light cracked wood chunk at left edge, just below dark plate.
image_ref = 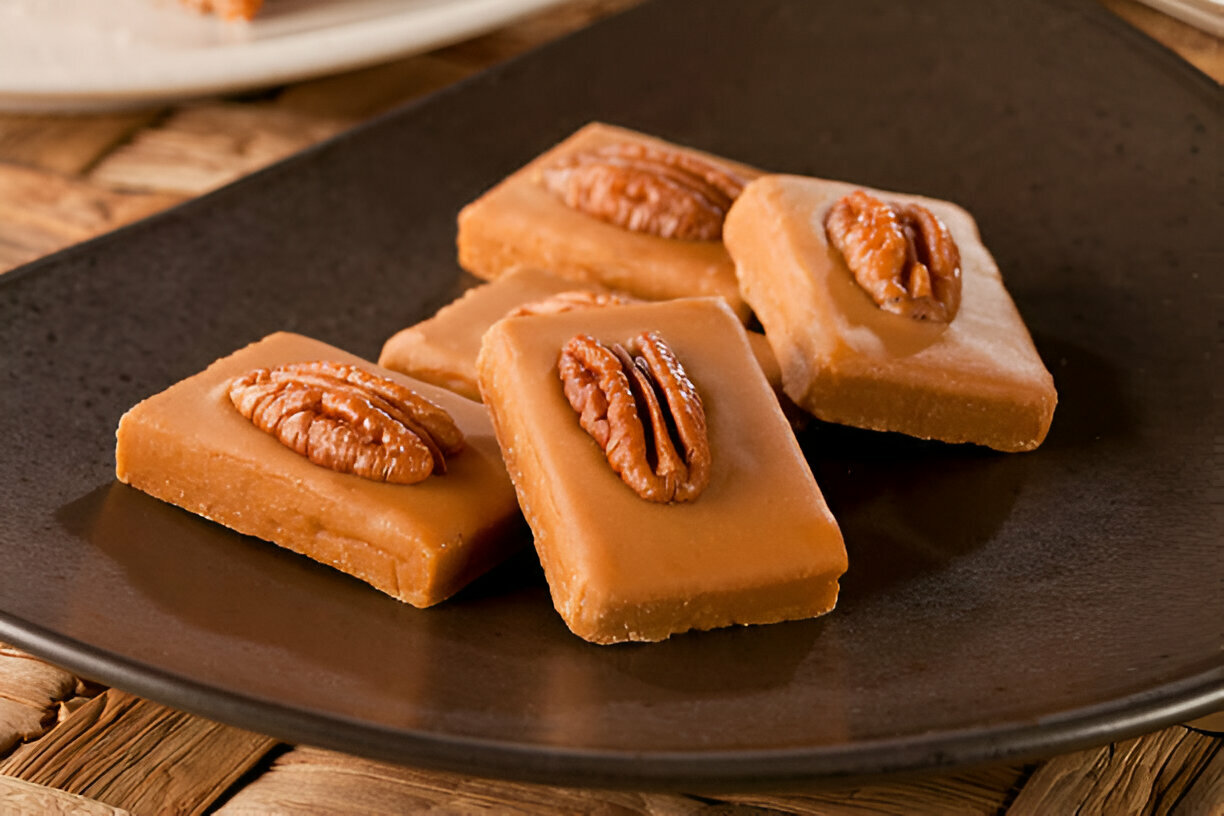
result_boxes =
[0,644,87,756]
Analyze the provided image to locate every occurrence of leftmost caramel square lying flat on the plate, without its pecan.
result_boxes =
[115,333,520,607]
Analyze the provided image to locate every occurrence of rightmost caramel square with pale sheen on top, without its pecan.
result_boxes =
[725,176,1058,450]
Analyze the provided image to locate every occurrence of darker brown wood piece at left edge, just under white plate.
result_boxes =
[0,108,162,175]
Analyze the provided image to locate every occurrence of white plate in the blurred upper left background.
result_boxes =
[0,0,564,111]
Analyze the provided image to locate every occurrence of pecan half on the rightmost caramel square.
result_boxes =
[825,190,961,323]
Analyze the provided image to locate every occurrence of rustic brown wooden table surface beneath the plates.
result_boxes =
[0,0,1224,816]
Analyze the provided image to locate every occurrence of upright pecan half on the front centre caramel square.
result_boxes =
[558,332,710,503]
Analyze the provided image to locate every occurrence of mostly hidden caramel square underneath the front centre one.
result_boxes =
[378,269,798,406]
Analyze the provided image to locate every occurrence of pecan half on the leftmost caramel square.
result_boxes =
[229,361,464,484]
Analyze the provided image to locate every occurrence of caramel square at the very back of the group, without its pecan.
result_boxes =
[459,124,760,318]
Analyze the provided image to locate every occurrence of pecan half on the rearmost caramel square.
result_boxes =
[543,142,747,241]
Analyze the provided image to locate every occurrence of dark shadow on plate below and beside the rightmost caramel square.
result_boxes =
[799,338,1135,610]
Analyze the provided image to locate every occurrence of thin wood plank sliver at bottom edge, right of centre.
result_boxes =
[721,765,1028,816]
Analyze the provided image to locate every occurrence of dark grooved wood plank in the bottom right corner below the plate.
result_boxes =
[1007,725,1224,816]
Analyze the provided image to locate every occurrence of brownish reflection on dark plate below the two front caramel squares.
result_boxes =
[58,482,821,719]
